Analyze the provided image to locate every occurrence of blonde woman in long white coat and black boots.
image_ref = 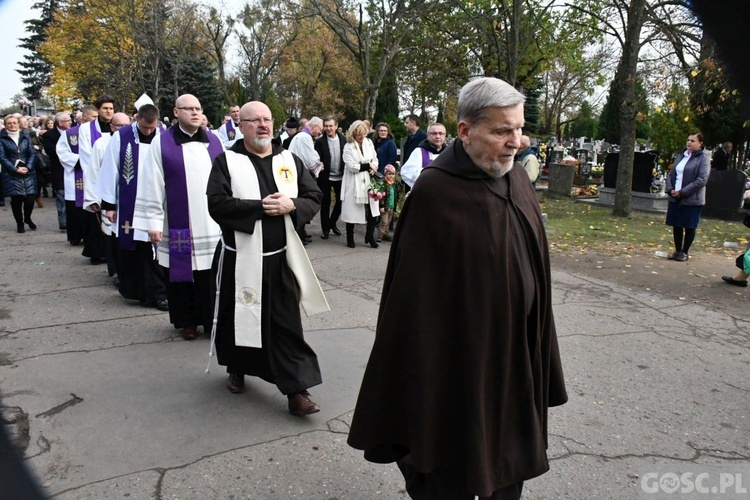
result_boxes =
[341,120,380,248]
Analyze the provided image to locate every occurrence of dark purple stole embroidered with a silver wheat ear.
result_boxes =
[117,125,140,251]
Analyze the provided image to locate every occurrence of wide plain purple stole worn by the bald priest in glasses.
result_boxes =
[161,125,224,283]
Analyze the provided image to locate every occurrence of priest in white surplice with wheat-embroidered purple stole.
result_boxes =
[96,98,169,311]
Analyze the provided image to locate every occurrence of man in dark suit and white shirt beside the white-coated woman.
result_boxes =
[315,115,346,240]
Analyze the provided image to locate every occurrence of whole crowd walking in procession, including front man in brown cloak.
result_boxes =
[0,78,567,499]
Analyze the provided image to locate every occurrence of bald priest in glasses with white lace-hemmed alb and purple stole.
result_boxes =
[134,94,224,340]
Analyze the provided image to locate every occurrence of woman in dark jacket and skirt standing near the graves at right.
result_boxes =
[666,132,711,262]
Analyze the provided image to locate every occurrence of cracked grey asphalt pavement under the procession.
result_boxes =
[0,204,750,500]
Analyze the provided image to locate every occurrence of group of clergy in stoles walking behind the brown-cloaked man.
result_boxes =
[56,94,329,416]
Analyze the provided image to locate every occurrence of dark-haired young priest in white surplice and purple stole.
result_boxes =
[75,95,115,264]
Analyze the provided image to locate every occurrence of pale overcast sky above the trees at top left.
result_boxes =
[0,0,239,107]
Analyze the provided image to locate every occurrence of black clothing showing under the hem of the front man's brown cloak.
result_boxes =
[396,455,523,500]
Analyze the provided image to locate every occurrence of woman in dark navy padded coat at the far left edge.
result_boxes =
[0,115,38,233]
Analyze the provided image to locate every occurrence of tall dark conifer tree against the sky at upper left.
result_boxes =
[16,0,62,99]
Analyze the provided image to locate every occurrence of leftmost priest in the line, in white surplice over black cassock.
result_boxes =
[55,104,99,245]
